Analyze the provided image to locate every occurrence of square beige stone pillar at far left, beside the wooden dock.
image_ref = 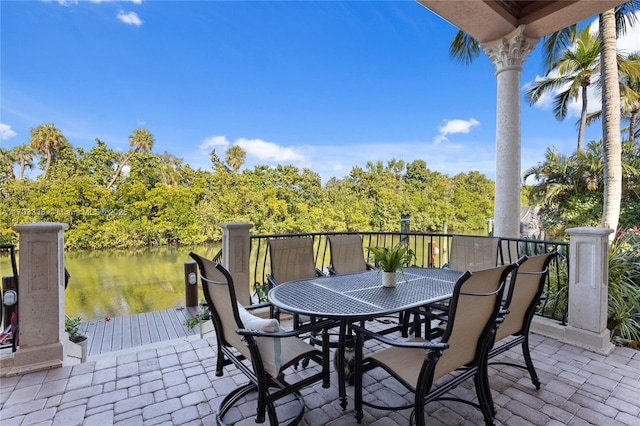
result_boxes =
[11,222,68,374]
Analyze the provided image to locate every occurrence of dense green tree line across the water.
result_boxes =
[0,124,494,249]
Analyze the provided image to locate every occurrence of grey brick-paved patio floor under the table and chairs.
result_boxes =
[0,314,640,426]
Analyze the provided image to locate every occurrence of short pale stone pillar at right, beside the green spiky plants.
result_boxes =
[565,227,614,354]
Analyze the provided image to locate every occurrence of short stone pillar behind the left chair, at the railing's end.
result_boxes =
[220,222,253,306]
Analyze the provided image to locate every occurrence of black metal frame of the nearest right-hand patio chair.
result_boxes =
[353,263,518,426]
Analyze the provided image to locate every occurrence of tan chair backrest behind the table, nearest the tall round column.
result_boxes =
[448,235,500,272]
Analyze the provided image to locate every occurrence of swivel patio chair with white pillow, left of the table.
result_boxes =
[189,253,330,425]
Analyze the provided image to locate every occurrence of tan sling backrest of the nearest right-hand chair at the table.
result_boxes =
[433,264,517,380]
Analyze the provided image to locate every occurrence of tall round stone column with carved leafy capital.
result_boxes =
[481,25,538,237]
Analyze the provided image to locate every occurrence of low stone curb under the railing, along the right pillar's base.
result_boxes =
[531,316,615,356]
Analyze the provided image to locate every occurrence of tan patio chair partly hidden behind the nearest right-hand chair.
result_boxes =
[482,252,558,409]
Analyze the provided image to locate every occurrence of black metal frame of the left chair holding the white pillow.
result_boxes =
[190,253,334,425]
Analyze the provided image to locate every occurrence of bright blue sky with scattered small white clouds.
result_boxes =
[0,0,640,182]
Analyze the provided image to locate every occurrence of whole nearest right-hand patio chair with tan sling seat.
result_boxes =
[353,264,517,426]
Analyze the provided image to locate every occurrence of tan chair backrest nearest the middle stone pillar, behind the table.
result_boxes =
[268,237,317,283]
